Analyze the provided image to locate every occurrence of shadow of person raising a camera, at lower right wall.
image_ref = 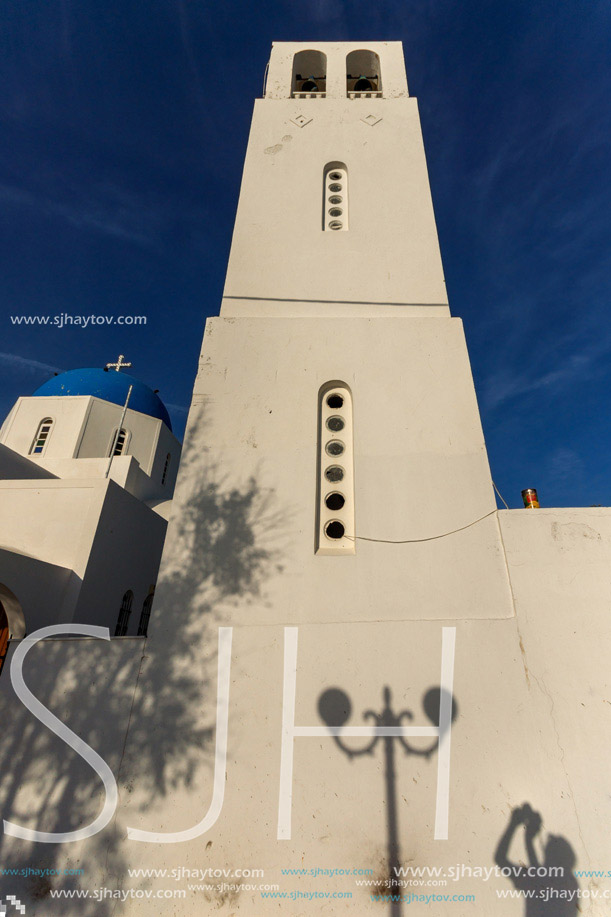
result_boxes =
[494,803,579,917]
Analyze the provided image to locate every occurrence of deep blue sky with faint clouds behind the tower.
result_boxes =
[0,0,611,507]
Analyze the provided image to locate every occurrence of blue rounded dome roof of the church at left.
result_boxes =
[34,369,172,430]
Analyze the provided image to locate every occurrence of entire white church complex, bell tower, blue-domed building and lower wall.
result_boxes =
[0,42,611,917]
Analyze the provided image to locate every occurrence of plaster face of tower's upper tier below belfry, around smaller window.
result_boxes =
[222,98,449,315]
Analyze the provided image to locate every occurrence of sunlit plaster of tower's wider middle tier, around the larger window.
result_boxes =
[184,318,511,622]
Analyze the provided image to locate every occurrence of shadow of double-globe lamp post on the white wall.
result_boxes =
[318,686,457,917]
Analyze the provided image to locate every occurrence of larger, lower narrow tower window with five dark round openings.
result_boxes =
[316,382,356,554]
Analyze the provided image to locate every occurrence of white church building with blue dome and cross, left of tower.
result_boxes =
[0,359,180,644]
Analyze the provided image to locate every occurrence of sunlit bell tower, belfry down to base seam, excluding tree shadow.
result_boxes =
[171,42,510,622]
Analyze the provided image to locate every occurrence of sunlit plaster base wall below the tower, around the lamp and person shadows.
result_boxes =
[0,504,611,917]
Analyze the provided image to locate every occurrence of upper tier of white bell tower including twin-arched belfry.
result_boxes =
[221,42,449,318]
